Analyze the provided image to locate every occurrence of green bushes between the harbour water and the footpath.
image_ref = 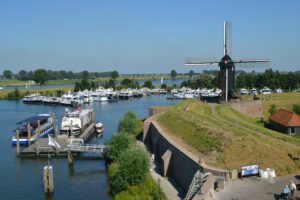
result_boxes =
[105,111,166,199]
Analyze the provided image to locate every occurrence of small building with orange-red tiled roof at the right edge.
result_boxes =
[270,109,300,135]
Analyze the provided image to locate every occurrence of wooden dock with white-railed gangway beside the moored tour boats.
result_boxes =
[20,123,106,156]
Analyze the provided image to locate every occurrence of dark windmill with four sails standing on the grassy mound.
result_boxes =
[185,21,270,102]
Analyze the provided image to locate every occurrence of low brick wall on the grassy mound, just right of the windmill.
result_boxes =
[231,100,263,118]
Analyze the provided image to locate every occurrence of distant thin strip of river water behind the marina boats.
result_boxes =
[3,79,187,90]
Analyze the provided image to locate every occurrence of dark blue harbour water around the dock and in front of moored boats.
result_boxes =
[0,95,178,200]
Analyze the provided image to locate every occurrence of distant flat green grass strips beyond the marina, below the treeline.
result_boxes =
[0,75,189,87]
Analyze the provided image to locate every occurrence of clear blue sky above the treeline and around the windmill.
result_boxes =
[0,0,300,73]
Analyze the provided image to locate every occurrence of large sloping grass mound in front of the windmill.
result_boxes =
[158,95,300,175]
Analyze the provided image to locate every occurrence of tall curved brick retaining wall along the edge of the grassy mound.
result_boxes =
[143,116,228,195]
